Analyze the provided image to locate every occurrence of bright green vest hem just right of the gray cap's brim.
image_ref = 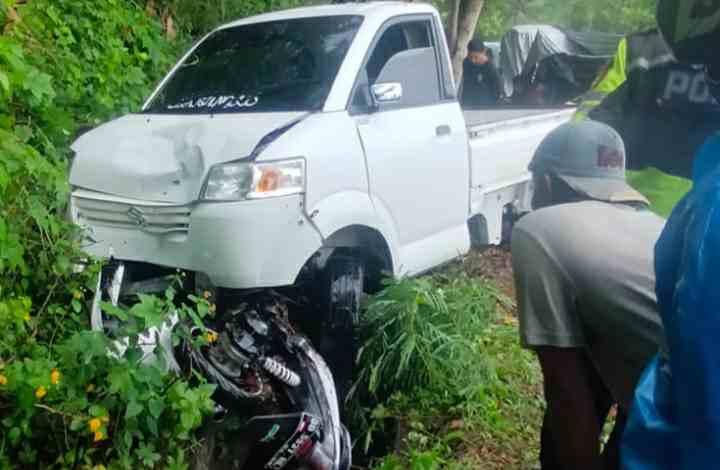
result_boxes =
[627,168,692,218]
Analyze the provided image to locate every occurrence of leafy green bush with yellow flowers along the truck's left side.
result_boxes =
[0,0,219,469]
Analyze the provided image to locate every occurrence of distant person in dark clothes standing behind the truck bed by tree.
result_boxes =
[460,39,501,108]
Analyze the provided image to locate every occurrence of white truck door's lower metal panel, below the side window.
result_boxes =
[357,99,470,275]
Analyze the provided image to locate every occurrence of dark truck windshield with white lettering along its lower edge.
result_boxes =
[146,16,362,114]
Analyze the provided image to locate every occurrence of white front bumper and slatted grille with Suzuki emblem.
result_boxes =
[71,189,322,289]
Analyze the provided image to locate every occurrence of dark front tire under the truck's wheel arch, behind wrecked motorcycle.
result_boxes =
[312,253,365,409]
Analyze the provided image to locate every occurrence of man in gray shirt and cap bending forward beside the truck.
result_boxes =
[512,121,664,470]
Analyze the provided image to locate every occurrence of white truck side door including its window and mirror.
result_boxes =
[350,15,469,274]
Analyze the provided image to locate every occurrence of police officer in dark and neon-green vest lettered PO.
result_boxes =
[575,25,720,216]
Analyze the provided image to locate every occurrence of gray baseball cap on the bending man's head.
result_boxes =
[529,120,649,204]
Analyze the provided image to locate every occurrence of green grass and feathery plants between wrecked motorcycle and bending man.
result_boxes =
[354,266,543,470]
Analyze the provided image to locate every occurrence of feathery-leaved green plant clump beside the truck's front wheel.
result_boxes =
[355,276,498,401]
